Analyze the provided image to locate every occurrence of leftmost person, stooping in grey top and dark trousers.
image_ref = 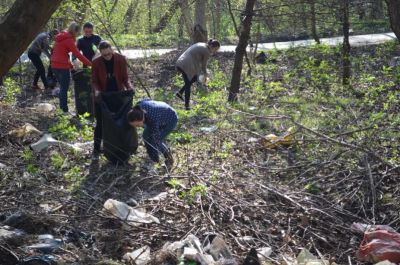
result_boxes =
[28,29,58,89]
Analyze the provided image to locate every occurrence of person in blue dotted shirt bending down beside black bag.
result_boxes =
[128,99,178,170]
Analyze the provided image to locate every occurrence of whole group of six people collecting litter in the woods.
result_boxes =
[28,22,220,169]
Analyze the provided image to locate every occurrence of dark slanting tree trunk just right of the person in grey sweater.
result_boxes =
[228,0,256,102]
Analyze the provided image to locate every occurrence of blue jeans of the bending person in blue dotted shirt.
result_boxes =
[143,119,178,162]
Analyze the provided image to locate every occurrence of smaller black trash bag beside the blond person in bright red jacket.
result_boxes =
[72,68,93,117]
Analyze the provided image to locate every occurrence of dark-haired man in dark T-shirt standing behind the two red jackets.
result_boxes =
[76,22,101,61]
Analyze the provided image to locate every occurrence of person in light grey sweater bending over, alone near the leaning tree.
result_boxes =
[176,39,221,110]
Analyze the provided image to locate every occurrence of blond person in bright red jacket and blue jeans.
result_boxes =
[50,22,92,113]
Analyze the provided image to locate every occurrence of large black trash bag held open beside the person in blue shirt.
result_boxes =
[101,91,138,164]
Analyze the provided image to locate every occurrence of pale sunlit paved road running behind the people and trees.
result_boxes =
[21,32,396,62]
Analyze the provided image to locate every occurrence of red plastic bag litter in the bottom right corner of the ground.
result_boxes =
[356,228,400,263]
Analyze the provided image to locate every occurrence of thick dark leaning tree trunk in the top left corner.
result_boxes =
[0,0,62,77]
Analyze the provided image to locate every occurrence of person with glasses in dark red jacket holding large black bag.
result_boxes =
[92,41,133,160]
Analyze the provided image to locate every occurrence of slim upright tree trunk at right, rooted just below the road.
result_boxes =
[341,0,351,85]
